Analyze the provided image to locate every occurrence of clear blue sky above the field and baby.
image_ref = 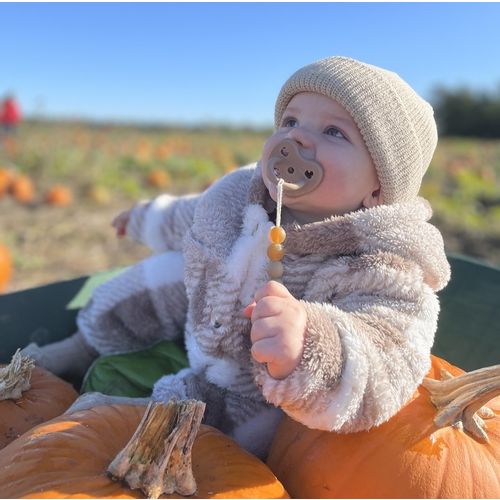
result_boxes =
[0,3,500,125]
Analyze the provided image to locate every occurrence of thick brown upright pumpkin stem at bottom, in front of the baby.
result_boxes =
[108,399,205,498]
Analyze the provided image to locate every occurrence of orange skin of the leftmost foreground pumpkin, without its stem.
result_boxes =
[0,367,78,452]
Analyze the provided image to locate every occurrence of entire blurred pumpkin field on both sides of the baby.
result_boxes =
[0,121,500,292]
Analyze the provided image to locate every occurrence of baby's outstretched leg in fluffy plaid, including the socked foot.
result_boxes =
[22,252,187,378]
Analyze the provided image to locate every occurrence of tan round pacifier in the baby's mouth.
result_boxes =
[263,139,323,197]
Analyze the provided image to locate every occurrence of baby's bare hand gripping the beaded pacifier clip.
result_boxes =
[244,281,307,379]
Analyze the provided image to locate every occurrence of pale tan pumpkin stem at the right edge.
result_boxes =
[422,365,500,443]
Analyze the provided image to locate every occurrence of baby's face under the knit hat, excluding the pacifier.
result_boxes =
[260,92,381,222]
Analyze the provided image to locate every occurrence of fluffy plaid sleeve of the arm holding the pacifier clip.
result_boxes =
[256,254,439,432]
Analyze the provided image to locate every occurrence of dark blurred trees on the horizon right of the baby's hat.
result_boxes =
[432,87,500,138]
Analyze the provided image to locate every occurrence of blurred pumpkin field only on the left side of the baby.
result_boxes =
[0,121,268,292]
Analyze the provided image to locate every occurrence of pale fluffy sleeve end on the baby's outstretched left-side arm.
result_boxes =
[127,194,201,253]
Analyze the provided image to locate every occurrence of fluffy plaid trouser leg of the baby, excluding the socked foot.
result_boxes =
[77,252,187,354]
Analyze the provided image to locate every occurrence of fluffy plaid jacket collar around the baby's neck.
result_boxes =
[247,164,450,289]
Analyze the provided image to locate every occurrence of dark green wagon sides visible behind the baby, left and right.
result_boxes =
[0,255,500,395]
